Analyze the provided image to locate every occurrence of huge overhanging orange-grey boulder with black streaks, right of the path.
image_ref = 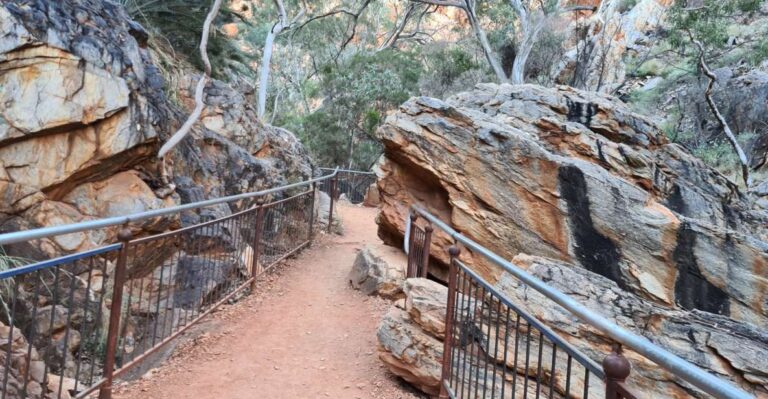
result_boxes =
[378,84,768,396]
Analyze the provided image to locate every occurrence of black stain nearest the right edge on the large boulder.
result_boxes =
[672,222,730,316]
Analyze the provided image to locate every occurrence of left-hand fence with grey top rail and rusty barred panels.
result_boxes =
[0,170,376,399]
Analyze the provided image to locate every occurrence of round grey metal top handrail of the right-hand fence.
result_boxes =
[406,205,754,399]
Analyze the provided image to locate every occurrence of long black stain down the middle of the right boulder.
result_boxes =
[558,166,628,290]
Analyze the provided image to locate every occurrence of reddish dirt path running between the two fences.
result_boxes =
[114,206,421,399]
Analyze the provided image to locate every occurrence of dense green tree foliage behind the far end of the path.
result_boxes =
[279,50,421,169]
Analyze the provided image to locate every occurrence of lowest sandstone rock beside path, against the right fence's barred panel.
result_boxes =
[377,307,443,395]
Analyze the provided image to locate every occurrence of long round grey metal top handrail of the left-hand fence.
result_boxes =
[0,168,340,245]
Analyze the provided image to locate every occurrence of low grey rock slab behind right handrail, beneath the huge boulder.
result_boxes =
[496,255,768,397]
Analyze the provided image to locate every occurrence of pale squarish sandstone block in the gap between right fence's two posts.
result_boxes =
[403,278,448,340]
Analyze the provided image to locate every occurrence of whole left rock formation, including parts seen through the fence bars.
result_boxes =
[0,0,312,397]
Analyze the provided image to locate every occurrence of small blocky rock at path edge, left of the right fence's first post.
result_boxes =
[348,246,407,298]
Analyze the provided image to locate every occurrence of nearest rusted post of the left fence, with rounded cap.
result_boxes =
[99,226,133,399]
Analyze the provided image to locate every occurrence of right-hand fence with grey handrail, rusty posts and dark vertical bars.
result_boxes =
[404,206,752,399]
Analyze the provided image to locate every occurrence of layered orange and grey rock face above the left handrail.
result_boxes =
[0,0,312,258]
